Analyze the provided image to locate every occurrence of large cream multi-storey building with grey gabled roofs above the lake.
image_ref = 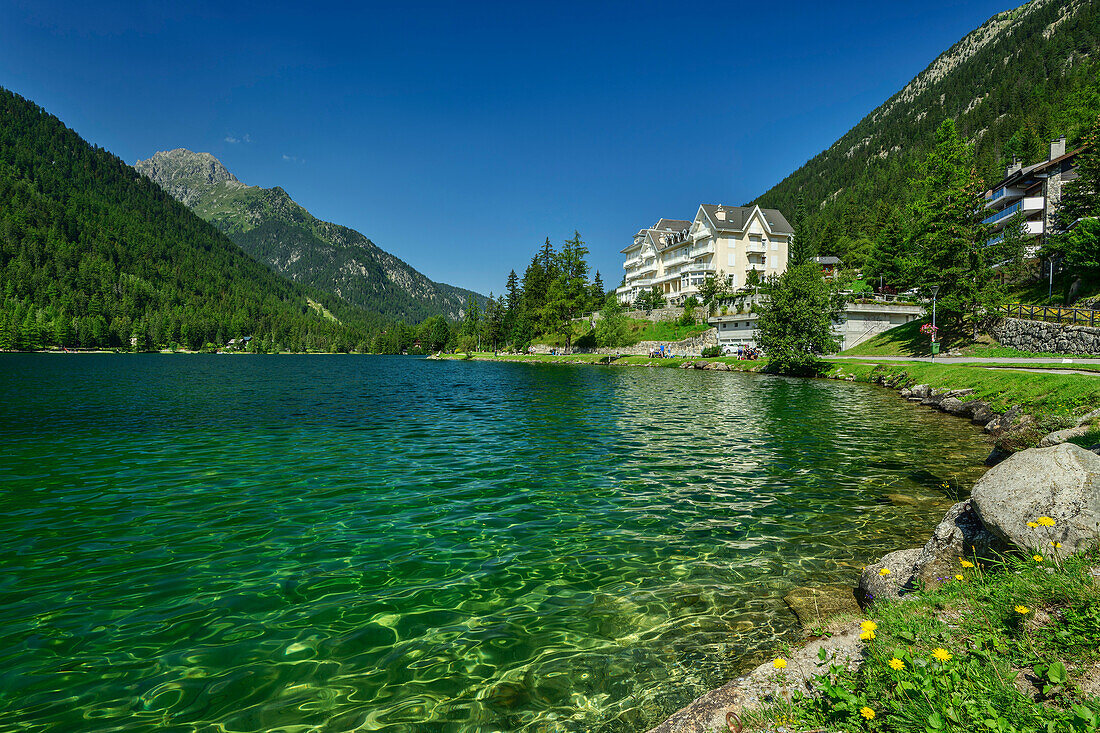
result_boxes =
[616,204,794,303]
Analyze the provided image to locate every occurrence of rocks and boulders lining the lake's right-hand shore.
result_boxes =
[648,372,1100,733]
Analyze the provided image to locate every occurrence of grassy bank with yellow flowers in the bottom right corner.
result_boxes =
[745,548,1100,733]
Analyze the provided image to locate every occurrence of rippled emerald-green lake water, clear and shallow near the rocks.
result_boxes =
[0,354,989,733]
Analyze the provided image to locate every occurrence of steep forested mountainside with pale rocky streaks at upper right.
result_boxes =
[755,0,1100,267]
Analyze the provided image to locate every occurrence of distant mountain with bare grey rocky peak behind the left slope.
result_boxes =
[134,149,485,321]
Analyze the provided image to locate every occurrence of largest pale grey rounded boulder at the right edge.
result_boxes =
[970,442,1100,556]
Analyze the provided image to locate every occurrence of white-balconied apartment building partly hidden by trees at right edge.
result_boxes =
[986,136,1081,258]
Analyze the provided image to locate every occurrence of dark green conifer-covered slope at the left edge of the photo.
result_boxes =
[0,88,378,350]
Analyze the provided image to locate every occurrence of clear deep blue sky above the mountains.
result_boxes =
[0,0,1016,293]
